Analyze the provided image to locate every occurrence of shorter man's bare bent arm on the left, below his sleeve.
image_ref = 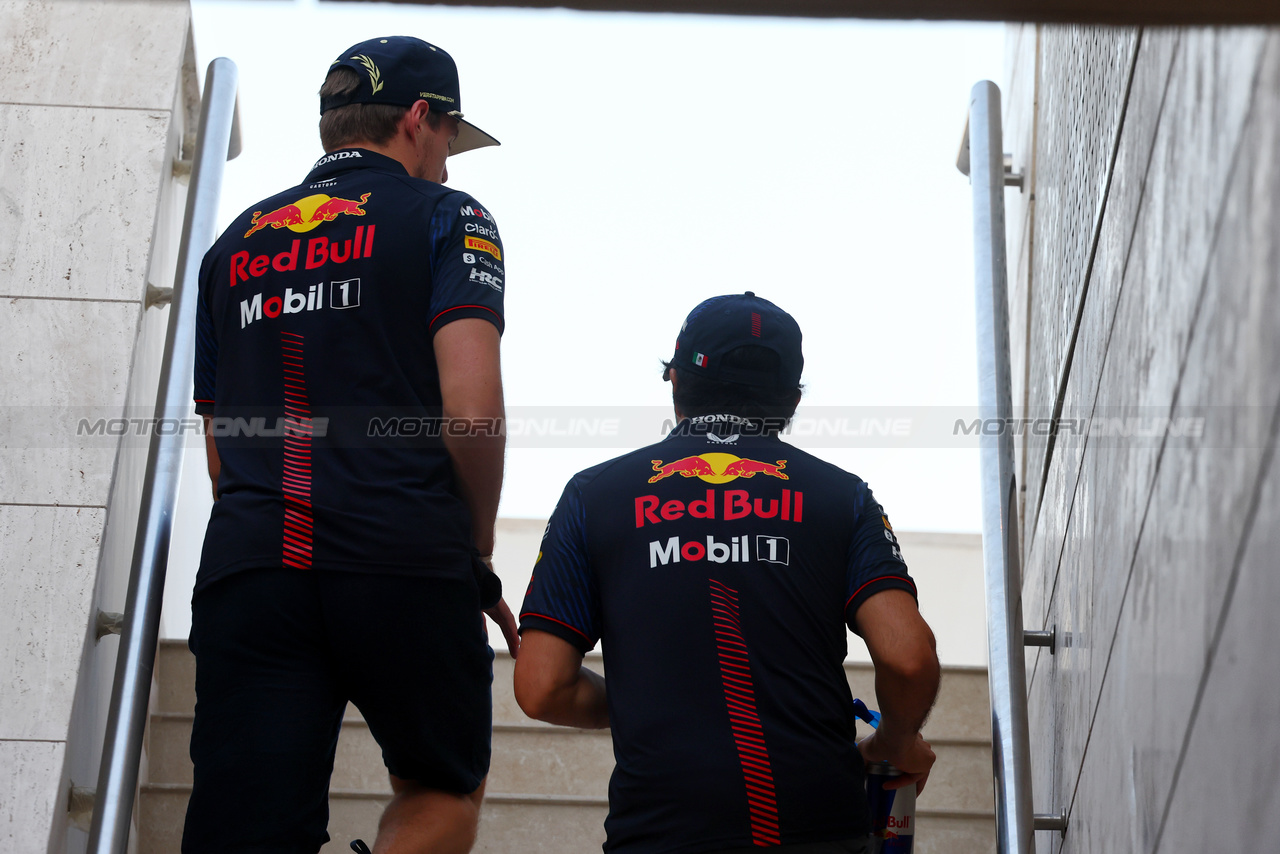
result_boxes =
[515,629,609,730]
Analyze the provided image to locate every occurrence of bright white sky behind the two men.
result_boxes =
[192,0,1004,531]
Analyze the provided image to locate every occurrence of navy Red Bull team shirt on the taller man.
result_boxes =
[195,149,506,593]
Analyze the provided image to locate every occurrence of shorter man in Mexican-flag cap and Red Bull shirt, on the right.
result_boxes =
[515,292,938,854]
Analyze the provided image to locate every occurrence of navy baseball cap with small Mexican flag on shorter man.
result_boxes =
[671,291,804,389]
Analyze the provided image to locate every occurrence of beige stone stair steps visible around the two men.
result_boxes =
[147,641,995,854]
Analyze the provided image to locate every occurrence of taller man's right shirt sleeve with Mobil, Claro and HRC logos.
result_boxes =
[429,193,507,335]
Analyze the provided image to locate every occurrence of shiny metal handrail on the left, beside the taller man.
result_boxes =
[87,58,239,854]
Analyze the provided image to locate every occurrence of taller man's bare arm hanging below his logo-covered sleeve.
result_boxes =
[433,318,507,554]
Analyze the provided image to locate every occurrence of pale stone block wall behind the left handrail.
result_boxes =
[0,0,198,854]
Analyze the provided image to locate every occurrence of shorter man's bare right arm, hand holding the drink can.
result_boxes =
[855,590,941,791]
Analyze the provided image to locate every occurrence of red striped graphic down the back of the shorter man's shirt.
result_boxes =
[710,579,782,846]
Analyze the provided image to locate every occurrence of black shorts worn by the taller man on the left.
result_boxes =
[182,568,493,854]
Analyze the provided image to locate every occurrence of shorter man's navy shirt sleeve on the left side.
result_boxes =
[520,481,600,653]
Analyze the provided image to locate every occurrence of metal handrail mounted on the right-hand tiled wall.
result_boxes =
[956,81,1066,854]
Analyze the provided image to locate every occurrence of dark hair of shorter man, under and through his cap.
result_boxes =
[662,344,804,421]
